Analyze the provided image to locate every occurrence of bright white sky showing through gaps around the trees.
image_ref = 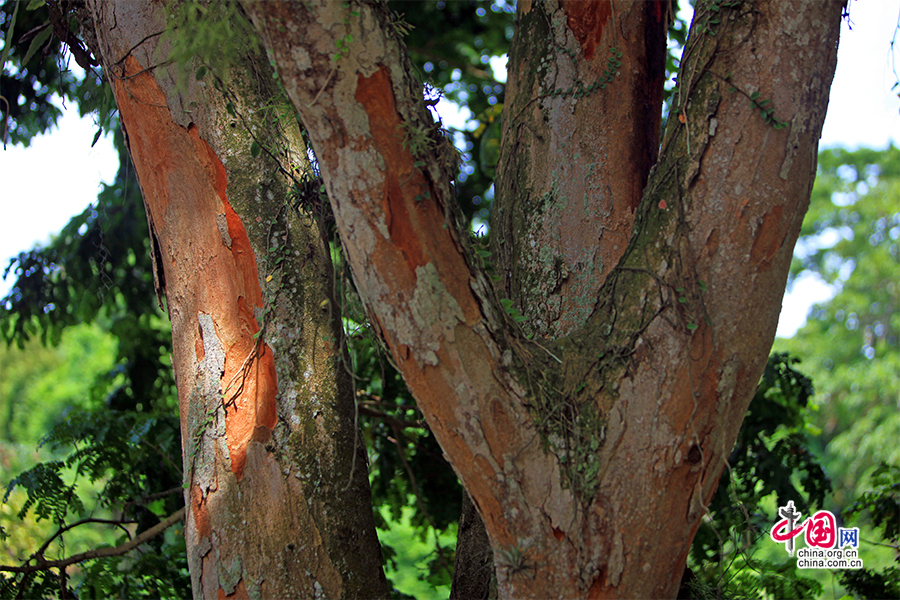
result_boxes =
[0,0,900,337]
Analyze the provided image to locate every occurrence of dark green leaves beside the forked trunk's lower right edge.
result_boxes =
[689,353,831,598]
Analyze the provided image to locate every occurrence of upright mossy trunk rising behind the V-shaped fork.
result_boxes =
[491,0,670,339]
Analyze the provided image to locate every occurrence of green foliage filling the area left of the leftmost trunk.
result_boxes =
[0,2,181,597]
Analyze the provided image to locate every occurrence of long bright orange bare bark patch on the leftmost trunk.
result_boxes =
[113,55,277,482]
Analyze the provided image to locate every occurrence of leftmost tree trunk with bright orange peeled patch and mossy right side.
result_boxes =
[85,0,389,598]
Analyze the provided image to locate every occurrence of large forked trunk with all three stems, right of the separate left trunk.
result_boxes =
[246,0,841,598]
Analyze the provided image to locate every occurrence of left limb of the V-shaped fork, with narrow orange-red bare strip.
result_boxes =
[245,2,553,539]
